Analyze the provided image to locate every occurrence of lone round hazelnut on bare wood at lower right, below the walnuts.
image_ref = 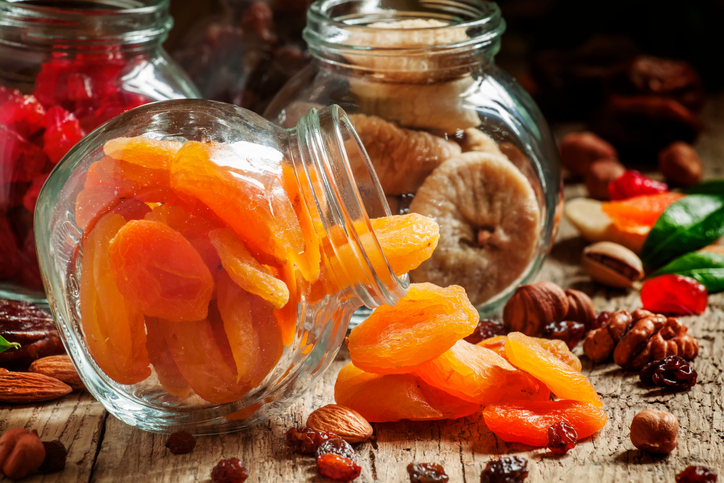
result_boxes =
[631,409,679,454]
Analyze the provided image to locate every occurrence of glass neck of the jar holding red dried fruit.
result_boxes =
[0,0,173,54]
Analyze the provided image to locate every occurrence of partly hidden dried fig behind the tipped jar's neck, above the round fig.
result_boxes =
[349,114,460,195]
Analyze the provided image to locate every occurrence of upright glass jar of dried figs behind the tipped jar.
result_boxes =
[264,0,562,316]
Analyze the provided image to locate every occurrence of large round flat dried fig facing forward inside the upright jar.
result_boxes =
[410,152,540,305]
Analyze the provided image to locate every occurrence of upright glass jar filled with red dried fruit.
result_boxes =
[0,0,198,301]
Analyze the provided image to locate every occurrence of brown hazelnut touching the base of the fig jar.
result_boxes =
[503,282,569,337]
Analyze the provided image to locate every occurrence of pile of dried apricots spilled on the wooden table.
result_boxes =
[335,283,607,446]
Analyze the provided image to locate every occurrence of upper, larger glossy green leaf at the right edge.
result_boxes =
[641,195,724,267]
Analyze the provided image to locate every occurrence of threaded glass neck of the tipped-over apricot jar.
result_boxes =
[289,105,408,308]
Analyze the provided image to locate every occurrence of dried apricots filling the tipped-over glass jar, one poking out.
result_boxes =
[75,137,439,404]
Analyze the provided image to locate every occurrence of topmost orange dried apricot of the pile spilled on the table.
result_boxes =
[347,283,479,374]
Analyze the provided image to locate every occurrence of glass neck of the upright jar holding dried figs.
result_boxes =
[304,0,505,78]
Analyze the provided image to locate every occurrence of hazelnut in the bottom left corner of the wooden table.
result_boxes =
[0,428,45,480]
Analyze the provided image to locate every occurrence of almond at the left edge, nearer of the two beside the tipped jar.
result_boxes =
[0,372,73,404]
